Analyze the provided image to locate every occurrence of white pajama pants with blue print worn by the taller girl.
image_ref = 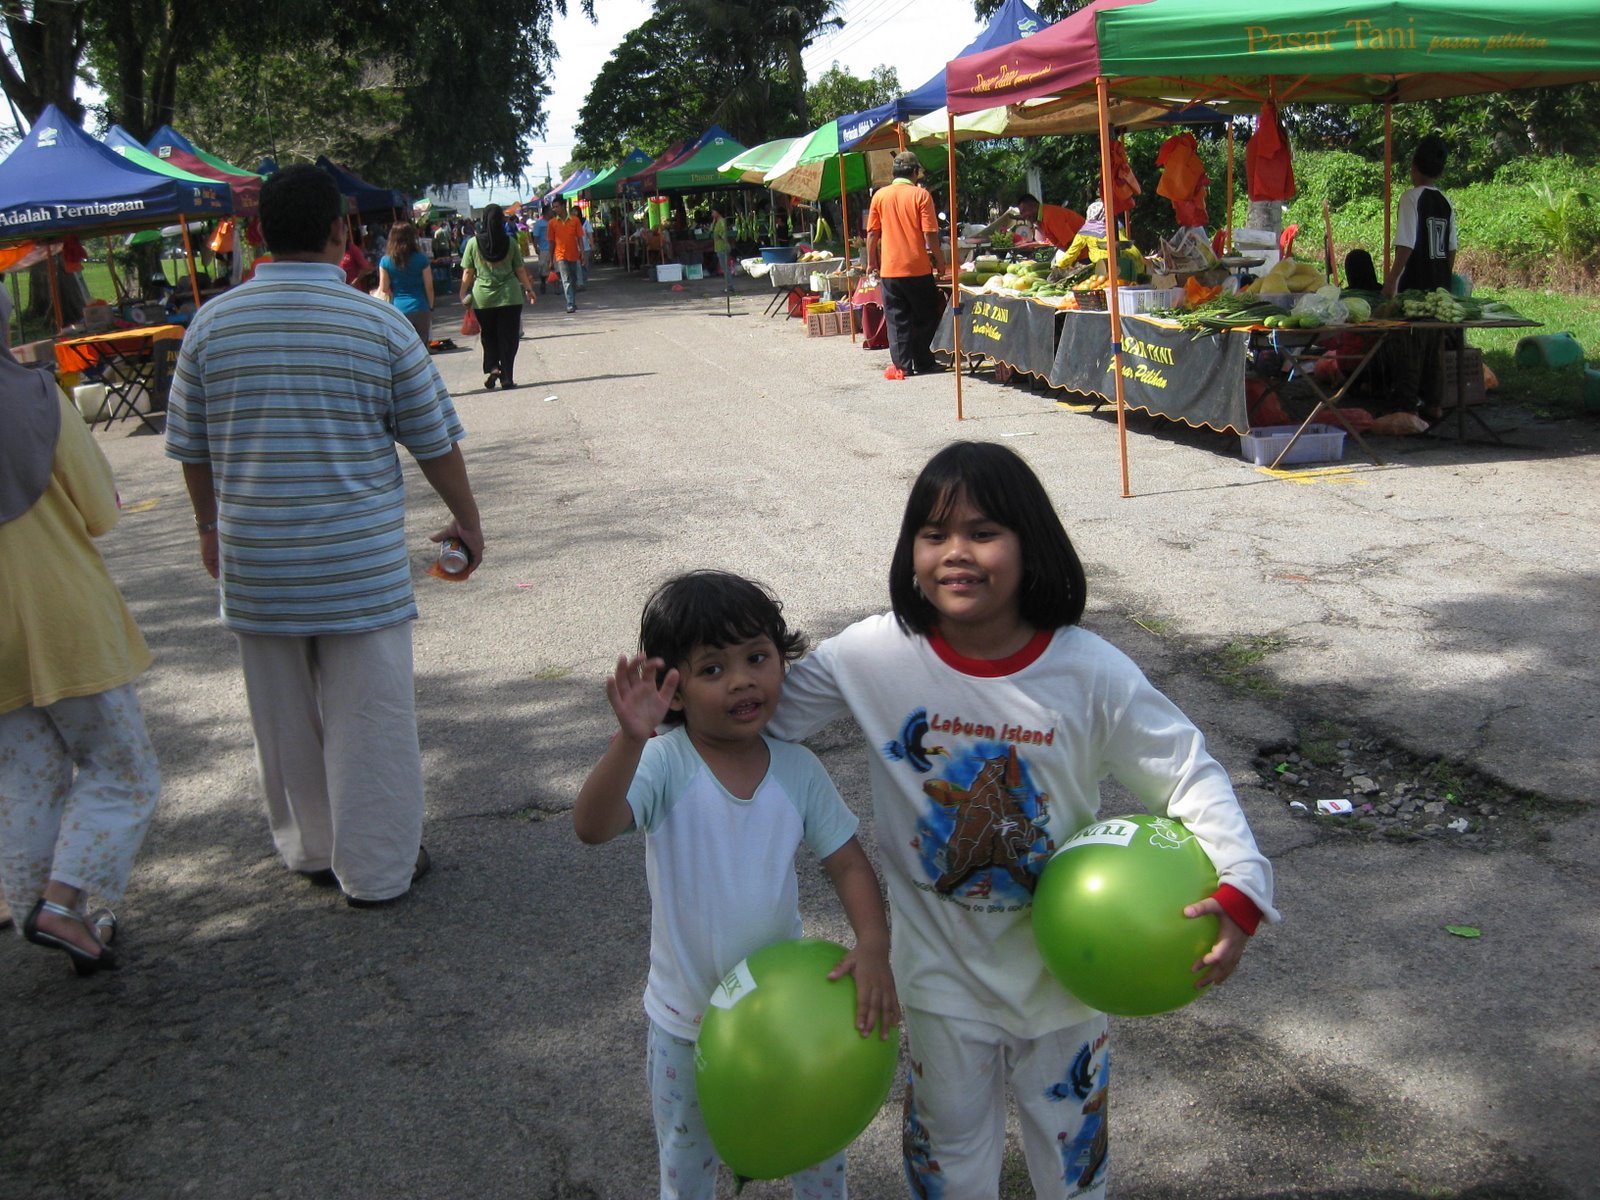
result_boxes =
[906,1008,1110,1200]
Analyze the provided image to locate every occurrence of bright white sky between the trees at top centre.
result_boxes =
[472,0,982,206]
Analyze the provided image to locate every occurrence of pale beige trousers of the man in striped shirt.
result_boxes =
[237,621,422,899]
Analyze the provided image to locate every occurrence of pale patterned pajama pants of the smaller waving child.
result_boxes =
[645,1021,848,1200]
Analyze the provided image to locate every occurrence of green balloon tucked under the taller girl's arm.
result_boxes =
[1034,813,1219,1016]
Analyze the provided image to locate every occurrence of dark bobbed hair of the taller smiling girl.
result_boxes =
[890,442,1086,637]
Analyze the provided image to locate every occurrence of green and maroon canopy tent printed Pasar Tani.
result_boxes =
[946,0,1600,496]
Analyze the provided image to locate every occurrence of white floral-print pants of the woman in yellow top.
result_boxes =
[0,683,162,908]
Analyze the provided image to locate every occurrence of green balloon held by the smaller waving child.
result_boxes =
[694,938,899,1179]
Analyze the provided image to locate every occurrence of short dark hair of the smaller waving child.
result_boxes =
[638,571,806,725]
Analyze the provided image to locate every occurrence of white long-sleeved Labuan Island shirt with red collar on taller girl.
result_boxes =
[770,614,1277,1037]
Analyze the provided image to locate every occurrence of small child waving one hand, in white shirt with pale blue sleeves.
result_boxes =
[573,571,899,1200]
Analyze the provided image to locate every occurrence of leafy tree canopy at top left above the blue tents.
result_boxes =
[0,0,594,186]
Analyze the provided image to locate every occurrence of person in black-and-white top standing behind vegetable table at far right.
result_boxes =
[1384,133,1461,421]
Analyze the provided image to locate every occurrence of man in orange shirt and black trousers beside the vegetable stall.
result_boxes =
[867,150,944,379]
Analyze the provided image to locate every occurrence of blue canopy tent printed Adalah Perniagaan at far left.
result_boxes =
[0,104,234,320]
